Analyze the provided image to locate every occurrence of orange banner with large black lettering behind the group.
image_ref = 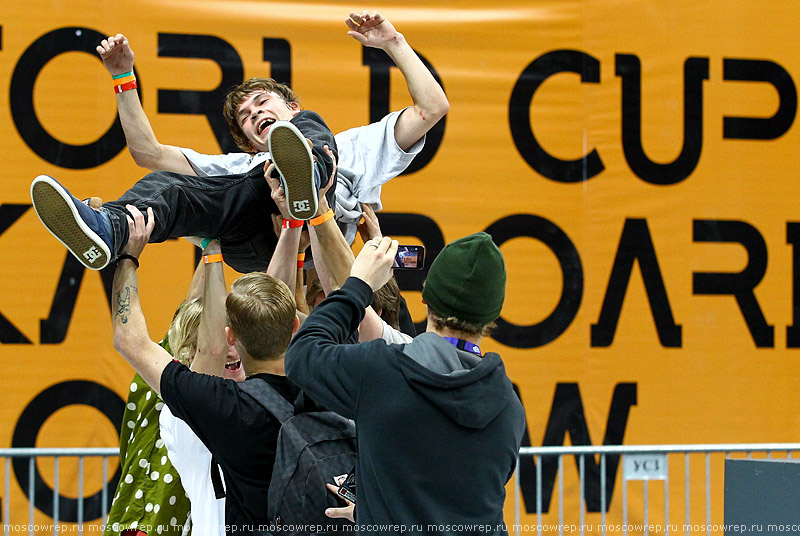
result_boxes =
[0,0,800,522]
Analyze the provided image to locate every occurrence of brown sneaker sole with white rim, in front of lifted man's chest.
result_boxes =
[269,123,317,220]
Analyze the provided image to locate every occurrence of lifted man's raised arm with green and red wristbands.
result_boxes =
[97,34,196,175]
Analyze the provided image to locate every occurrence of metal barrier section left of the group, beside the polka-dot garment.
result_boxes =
[0,448,119,536]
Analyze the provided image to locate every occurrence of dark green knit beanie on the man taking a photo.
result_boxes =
[422,232,506,325]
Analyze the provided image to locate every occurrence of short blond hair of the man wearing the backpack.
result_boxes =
[225,272,297,361]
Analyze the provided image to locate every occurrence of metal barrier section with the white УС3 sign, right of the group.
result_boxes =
[509,443,800,536]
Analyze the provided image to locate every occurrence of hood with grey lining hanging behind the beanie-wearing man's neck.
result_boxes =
[396,333,516,429]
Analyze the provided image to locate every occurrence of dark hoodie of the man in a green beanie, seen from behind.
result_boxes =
[286,277,525,535]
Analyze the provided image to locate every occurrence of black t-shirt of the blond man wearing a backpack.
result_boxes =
[161,361,300,536]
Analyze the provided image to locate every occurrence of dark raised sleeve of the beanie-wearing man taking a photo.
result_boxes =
[286,277,386,418]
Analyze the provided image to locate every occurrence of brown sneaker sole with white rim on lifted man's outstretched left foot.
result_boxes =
[31,175,111,270]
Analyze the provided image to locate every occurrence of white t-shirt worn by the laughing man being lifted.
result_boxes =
[181,110,425,243]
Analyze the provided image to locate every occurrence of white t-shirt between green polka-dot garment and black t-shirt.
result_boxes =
[158,404,225,536]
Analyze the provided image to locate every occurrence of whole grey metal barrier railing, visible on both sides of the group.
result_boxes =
[0,443,800,536]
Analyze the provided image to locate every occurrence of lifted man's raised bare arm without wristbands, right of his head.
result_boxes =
[345,11,450,151]
